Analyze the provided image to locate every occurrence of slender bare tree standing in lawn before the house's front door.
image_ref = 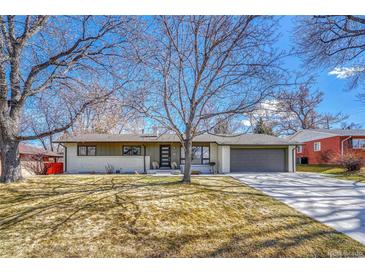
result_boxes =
[129,16,282,183]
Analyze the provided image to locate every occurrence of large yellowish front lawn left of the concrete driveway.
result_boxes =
[0,175,365,257]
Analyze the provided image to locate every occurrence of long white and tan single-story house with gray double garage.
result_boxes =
[56,134,297,173]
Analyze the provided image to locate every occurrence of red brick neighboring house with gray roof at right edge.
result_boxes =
[288,129,365,164]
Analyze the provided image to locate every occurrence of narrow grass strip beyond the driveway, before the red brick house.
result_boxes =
[297,165,365,182]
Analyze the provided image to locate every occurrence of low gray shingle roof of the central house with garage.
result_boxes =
[55,134,297,145]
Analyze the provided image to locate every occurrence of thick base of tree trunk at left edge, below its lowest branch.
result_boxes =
[0,140,22,183]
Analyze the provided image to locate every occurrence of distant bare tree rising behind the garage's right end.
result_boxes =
[272,86,347,134]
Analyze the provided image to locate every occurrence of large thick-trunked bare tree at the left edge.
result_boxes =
[0,16,135,182]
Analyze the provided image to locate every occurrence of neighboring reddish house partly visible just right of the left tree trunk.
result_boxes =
[0,143,63,176]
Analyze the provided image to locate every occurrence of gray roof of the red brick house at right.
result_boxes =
[288,129,365,142]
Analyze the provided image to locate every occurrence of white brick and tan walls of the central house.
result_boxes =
[64,143,295,173]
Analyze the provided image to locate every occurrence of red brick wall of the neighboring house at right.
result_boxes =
[297,136,365,164]
